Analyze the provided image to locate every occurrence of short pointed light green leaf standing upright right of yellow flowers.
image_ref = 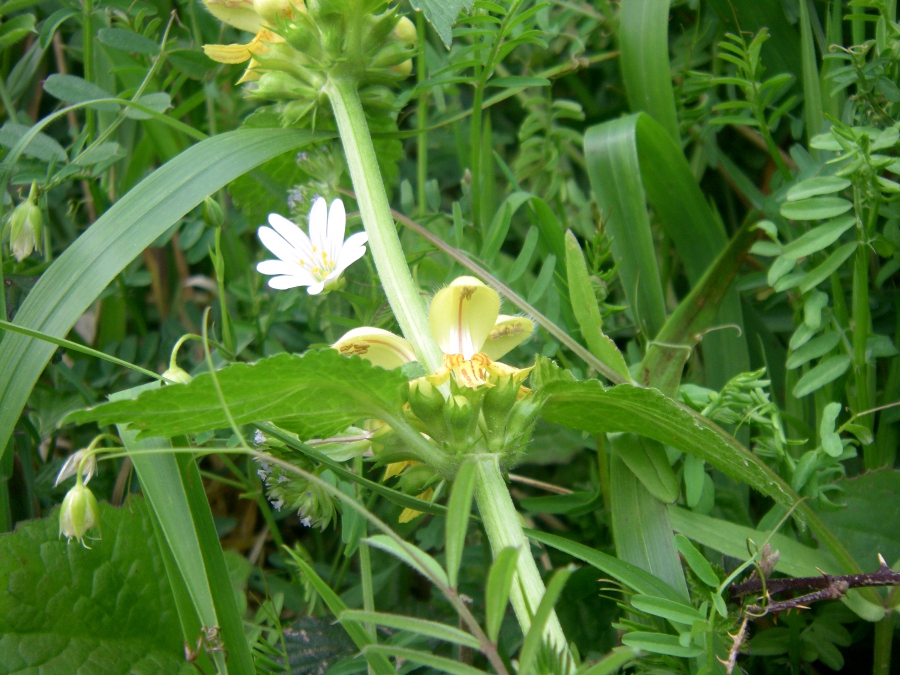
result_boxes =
[566,230,631,381]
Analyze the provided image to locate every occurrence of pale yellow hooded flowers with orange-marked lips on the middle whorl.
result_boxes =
[332,277,534,388]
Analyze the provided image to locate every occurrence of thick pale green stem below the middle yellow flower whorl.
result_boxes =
[475,454,568,650]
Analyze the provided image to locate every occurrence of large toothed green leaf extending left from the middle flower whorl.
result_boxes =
[71,349,407,438]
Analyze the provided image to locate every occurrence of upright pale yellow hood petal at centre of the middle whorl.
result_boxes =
[428,277,500,360]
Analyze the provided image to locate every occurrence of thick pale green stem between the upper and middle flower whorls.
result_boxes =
[325,76,443,372]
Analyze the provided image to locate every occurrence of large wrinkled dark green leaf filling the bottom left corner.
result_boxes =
[0,496,194,675]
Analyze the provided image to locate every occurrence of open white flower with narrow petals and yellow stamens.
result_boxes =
[256,197,369,295]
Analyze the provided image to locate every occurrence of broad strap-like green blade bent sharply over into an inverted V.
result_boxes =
[584,112,749,388]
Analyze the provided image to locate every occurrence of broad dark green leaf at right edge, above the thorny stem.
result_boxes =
[820,469,900,570]
